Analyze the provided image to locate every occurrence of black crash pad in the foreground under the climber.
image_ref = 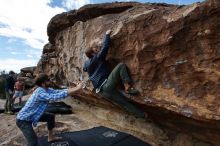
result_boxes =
[38,126,150,146]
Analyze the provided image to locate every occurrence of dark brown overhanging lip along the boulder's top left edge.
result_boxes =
[47,3,142,44]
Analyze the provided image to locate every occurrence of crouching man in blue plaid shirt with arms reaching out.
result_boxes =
[16,74,83,146]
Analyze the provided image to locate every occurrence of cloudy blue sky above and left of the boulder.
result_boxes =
[0,0,203,73]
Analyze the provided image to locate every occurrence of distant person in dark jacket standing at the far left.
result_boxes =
[5,71,15,114]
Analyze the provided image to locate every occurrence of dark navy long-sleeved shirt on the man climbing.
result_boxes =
[83,35,111,88]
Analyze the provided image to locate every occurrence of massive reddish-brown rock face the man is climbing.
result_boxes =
[35,0,220,145]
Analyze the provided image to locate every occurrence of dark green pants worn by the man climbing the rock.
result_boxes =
[100,63,144,118]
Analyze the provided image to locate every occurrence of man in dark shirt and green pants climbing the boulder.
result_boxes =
[83,30,147,118]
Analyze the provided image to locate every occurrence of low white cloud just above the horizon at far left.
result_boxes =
[0,59,38,73]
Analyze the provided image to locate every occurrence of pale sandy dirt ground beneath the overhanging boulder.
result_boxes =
[0,99,159,146]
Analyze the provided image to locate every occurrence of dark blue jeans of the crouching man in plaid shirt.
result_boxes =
[16,113,55,146]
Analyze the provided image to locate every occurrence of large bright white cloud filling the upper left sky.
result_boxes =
[0,0,66,49]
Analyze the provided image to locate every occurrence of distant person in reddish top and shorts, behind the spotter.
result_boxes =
[12,77,25,107]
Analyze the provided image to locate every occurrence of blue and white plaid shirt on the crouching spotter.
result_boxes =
[17,87,68,126]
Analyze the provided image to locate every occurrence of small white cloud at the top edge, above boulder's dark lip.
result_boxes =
[62,0,92,10]
